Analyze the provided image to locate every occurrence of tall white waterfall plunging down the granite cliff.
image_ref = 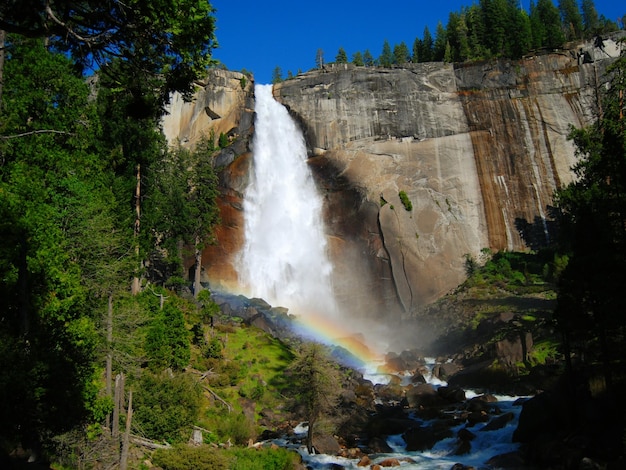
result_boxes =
[238,85,335,315]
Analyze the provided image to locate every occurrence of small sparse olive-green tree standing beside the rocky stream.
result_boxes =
[290,343,341,453]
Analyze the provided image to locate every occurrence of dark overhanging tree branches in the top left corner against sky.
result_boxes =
[2,0,216,107]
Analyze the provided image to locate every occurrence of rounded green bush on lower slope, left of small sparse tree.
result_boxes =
[133,373,202,443]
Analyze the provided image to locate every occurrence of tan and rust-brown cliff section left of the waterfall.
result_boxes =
[162,69,254,288]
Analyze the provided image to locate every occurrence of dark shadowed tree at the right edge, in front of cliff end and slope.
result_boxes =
[555,46,626,374]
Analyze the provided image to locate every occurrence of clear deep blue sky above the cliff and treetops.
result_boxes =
[211,0,626,83]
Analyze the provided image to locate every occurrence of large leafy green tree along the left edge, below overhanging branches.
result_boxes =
[0,36,112,438]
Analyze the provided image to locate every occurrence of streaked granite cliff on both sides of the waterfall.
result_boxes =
[164,35,619,316]
